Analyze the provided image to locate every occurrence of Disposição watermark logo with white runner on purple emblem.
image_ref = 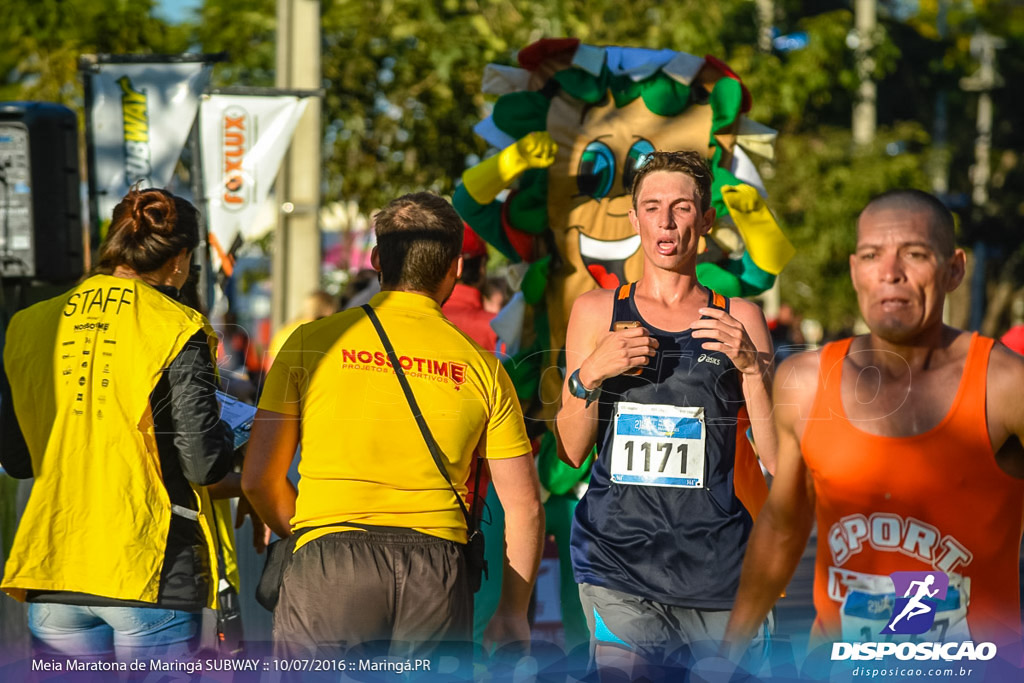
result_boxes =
[831,571,996,661]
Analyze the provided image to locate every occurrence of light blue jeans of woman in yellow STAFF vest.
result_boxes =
[29,602,202,661]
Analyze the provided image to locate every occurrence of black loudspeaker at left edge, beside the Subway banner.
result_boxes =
[0,102,85,283]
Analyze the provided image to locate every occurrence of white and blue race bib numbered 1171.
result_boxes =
[609,402,705,488]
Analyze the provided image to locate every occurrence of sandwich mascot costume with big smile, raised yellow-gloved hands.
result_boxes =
[454,38,794,648]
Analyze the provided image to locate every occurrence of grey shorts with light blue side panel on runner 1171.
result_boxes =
[580,584,774,667]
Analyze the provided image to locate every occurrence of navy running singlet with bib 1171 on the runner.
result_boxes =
[571,283,753,609]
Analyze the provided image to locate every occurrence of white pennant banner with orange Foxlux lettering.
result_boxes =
[199,94,308,278]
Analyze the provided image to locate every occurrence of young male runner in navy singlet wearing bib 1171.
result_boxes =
[558,152,775,680]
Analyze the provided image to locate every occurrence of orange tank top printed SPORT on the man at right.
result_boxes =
[801,334,1024,644]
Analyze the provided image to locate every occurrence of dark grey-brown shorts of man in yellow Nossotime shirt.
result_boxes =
[273,527,473,657]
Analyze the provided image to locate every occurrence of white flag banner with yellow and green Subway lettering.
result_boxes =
[86,55,211,221]
